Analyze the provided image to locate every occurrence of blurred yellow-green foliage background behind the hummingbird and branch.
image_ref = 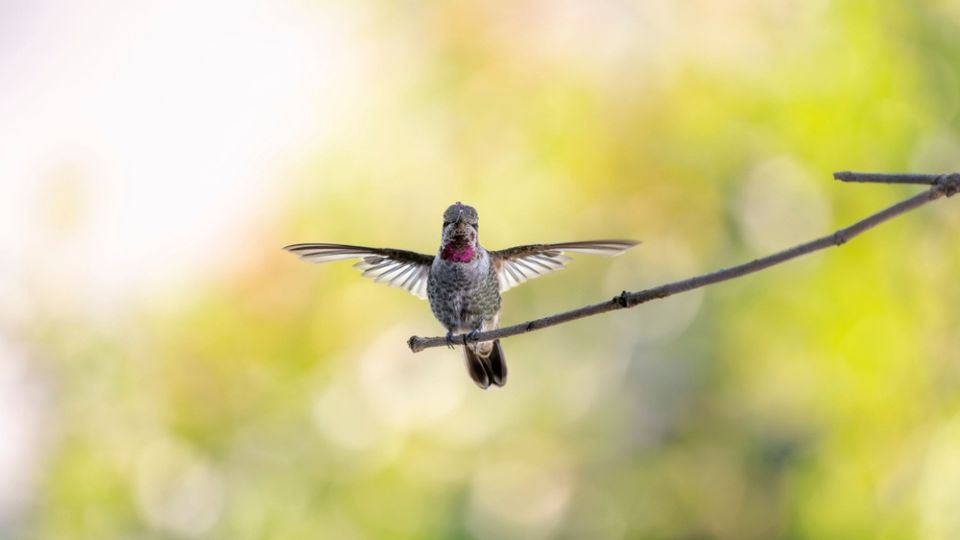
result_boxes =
[0,0,960,540]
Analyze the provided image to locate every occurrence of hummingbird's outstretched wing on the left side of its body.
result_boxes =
[283,244,433,299]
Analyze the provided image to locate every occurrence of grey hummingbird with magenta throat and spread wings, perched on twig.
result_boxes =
[283,201,639,389]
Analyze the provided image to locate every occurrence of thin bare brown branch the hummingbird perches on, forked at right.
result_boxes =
[407,171,960,352]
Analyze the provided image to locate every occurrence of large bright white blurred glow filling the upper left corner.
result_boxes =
[0,0,369,315]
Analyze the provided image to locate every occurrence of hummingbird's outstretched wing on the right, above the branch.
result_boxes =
[490,240,640,292]
